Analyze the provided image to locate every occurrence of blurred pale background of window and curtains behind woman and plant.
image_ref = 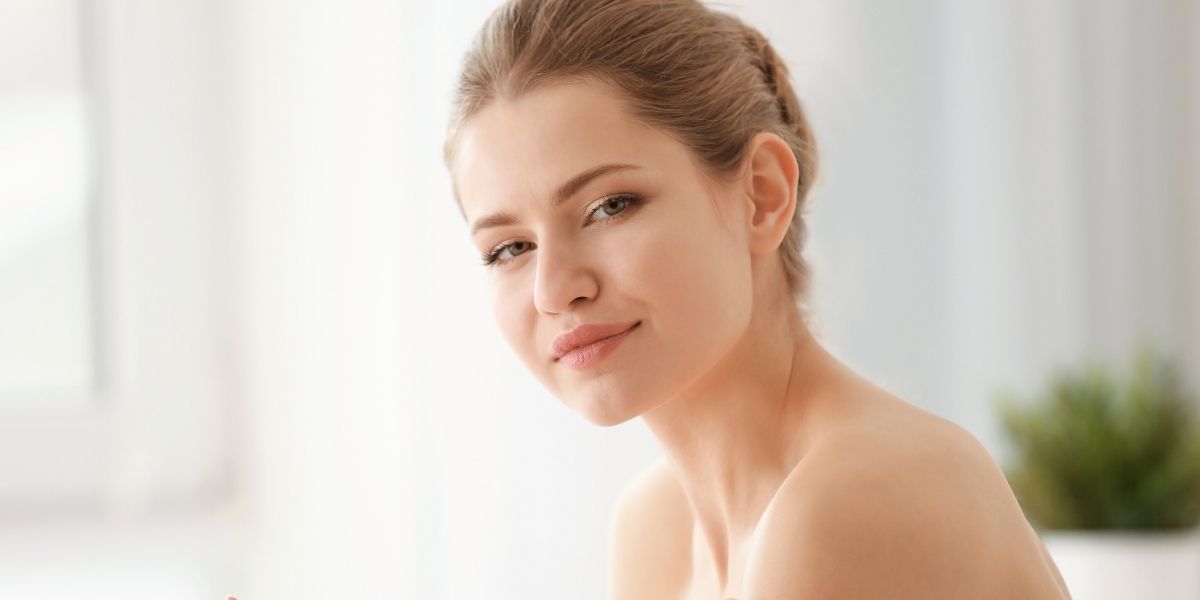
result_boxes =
[0,0,1200,600]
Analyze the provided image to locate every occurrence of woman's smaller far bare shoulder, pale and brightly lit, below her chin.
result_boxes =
[608,460,691,600]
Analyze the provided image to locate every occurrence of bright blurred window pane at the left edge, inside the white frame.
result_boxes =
[0,0,95,414]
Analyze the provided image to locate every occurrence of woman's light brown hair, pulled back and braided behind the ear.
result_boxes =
[444,0,817,302]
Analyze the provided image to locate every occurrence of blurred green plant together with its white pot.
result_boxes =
[996,348,1200,600]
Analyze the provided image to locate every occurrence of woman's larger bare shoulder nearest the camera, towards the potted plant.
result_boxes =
[744,404,1063,599]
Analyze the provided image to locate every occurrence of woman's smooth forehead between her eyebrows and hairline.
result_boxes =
[454,83,686,220]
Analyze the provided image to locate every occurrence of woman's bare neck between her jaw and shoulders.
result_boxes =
[643,291,836,587]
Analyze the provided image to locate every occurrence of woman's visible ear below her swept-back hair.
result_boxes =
[743,132,800,256]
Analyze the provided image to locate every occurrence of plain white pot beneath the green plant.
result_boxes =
[1038,528,1200,600]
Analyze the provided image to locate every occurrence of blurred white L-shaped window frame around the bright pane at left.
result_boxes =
[0,0,235,518]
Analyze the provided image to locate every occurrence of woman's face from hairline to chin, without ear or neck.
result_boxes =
[452,83,752,425]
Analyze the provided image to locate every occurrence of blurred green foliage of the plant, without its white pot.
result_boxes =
[996,348,1200,529]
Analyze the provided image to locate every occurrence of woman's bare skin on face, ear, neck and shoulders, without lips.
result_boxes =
[451,80,1069,600]
